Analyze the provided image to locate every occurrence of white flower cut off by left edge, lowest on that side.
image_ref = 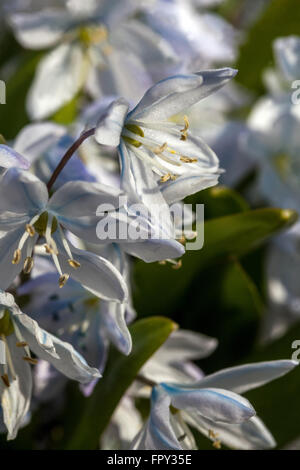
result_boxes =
[0,291,100,439]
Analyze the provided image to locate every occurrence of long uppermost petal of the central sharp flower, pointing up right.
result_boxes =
[128,68,236,122]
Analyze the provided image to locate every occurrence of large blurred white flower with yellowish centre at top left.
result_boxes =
[9,0,177,119]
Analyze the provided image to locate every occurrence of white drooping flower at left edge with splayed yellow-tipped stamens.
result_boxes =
[0,163,127,302]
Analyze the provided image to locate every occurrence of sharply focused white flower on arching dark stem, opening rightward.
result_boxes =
[95,68,236,205]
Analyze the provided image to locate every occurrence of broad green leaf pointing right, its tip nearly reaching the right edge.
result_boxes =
[134,209,297,316]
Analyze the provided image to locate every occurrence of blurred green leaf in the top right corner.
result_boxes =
[237,0,300,93]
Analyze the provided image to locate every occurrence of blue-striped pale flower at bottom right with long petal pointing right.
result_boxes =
[132,360,298,450]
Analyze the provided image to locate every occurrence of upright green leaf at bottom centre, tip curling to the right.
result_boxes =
[67,317,177,449]
